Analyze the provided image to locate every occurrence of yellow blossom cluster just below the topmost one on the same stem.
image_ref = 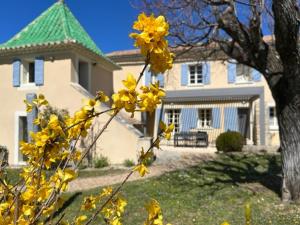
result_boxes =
[112,74,165,116]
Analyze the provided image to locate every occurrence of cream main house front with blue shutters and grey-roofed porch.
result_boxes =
[108,46,279,146]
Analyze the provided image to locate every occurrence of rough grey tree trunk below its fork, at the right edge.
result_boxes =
[276,93,300,202]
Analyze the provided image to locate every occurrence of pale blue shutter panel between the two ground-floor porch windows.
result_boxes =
[180,108,198,131]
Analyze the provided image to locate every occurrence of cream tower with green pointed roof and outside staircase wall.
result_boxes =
[0,1,144,165]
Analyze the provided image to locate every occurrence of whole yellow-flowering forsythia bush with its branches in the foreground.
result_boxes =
[0,11,250,225]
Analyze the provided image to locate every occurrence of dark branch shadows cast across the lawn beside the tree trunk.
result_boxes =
[165,153,282,196]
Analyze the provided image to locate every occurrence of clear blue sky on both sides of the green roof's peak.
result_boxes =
[0,0,139,53]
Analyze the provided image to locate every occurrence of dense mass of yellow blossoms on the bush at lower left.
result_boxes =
[0,92,108,225]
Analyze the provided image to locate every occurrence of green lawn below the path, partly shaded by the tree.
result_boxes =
[55,154,300,225]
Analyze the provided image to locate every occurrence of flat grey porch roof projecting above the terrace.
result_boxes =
[164,87,264,103]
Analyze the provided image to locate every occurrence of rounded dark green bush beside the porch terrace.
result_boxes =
[216,131,245,152]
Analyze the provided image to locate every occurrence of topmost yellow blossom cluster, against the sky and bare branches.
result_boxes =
[130,13,174,74]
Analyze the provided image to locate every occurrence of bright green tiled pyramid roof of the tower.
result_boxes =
[0,1,105,57]
